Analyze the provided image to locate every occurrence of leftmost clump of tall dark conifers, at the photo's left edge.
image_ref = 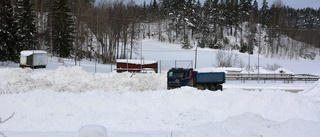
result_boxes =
[0,0,37,62]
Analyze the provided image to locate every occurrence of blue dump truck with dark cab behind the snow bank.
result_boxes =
[167,68,226,91]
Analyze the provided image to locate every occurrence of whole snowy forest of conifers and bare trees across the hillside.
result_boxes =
[0,0,320,63]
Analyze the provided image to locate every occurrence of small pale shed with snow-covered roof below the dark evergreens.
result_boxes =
[20,50,47,68]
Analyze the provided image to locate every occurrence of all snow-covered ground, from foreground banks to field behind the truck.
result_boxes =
[0,40,320,137]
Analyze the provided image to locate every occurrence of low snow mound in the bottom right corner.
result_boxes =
[185,113,320,137]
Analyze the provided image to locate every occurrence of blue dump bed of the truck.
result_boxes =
[196,72,226,84]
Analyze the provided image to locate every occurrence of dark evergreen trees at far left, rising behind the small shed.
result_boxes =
[0,0,74,62]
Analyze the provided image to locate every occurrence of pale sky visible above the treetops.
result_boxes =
[129,0,320,9]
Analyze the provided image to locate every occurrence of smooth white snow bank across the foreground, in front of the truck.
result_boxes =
[0,87,320,135]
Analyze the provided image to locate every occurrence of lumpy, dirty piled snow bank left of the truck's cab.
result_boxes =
[0,67,166,94]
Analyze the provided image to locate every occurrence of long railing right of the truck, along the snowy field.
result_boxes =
[226,73,319,83]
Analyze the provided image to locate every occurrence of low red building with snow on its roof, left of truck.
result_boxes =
[116,59,158,73]
